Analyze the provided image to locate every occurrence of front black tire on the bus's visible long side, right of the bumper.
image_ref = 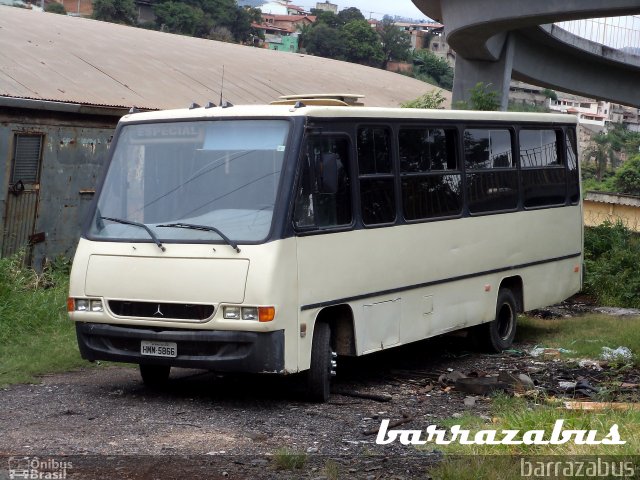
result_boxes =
[307,322,332,403]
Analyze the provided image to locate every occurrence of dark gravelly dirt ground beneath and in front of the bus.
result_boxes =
[0,298,640,480]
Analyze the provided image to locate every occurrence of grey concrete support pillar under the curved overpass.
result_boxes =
[452,35,514,111]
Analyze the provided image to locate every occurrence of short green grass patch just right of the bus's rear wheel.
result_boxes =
[516,315,640,366]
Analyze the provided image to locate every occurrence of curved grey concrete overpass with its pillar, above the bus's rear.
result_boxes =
[412,0,640,109]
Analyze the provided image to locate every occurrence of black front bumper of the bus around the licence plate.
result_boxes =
[76,322,284,373]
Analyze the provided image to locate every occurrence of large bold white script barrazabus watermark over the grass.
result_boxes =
[376,419,627,445]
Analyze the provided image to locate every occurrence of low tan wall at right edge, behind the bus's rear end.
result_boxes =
[583,192,640,232]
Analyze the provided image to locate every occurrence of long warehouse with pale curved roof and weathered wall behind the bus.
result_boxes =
[0,6,440,266]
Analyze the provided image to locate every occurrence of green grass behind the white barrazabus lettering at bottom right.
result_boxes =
[418,395,640,480]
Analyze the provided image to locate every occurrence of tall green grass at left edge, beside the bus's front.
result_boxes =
[0,254,86,386]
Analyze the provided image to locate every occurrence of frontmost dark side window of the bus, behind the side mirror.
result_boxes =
[293,136,352,229]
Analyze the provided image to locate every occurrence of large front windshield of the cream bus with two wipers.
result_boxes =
[89,120,289,244]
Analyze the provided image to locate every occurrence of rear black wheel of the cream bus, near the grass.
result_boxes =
[478,288,518,353]
